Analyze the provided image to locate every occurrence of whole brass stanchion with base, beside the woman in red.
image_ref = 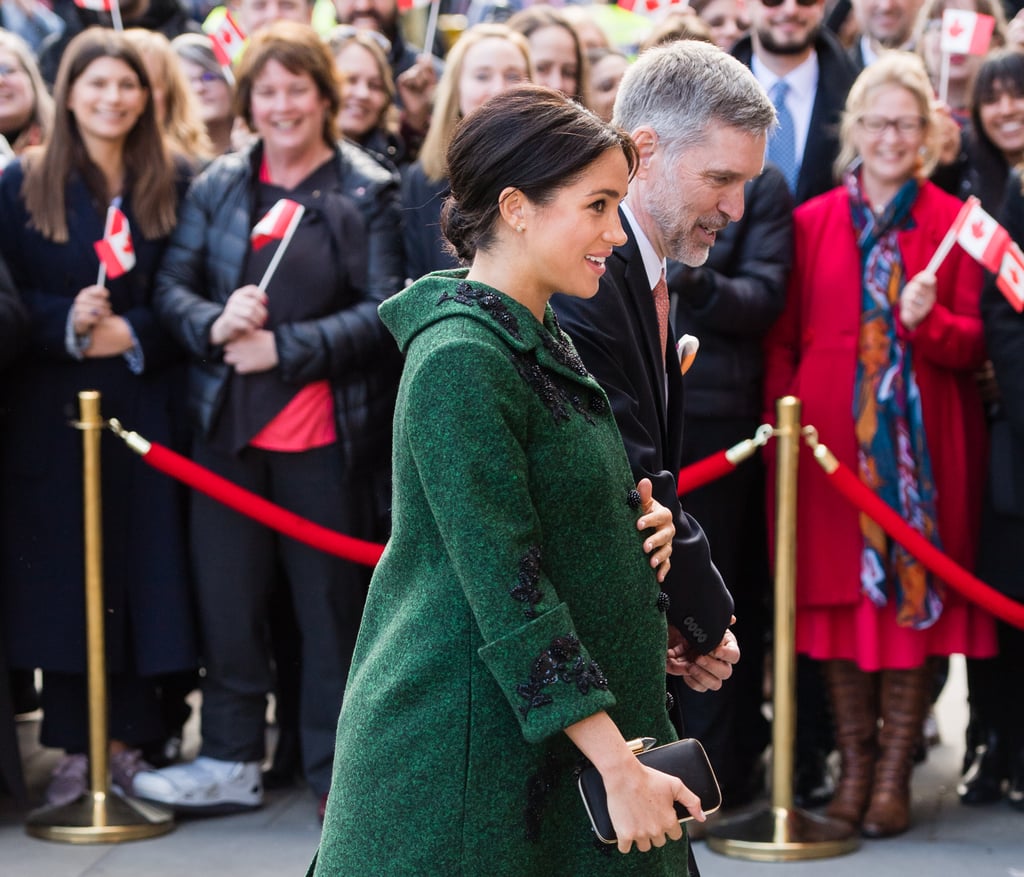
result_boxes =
[708,396,859,862]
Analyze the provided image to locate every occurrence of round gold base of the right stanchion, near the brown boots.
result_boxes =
[708,807,860,862]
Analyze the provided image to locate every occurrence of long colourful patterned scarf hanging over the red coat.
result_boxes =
[845,168,943,630]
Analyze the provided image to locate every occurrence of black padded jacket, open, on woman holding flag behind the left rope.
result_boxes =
[154,142,404,468]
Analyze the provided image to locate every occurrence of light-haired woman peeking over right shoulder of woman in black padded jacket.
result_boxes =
[328,25,408,169]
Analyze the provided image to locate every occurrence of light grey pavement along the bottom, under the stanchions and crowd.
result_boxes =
[0,659,1024,877]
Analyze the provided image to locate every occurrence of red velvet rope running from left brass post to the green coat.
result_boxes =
[142,444,384,567]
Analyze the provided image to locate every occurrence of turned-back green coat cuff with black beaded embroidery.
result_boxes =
[479,603,615,743]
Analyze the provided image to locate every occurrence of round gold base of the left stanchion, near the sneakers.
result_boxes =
[25,792,174,843]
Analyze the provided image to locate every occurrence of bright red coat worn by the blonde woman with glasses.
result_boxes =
[765,183,985,607]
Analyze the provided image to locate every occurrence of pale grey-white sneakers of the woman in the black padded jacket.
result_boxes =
[133,755,263,816]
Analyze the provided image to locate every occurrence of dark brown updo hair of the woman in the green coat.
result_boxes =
[441,85,638,262]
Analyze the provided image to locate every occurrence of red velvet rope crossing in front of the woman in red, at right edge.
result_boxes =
[826,463,1024,630]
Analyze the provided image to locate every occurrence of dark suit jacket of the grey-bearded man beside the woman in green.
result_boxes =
[551,214,733,654]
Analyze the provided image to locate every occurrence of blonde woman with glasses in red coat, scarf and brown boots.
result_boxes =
[765,52,995,837]
